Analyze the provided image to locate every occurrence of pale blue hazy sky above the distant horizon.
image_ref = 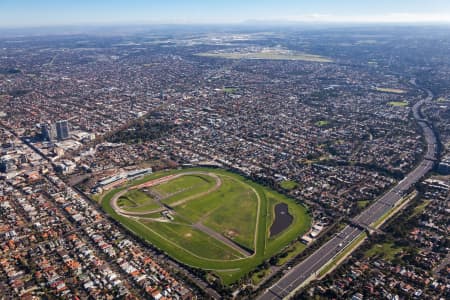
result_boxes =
[0,0,450,27]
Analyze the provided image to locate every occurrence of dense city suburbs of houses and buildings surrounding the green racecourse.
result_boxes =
[0,29,450,300]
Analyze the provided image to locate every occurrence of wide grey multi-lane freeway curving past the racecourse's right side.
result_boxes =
[259,91,437,300]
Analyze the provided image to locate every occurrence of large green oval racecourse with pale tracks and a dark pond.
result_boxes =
[101,168,311,284]
